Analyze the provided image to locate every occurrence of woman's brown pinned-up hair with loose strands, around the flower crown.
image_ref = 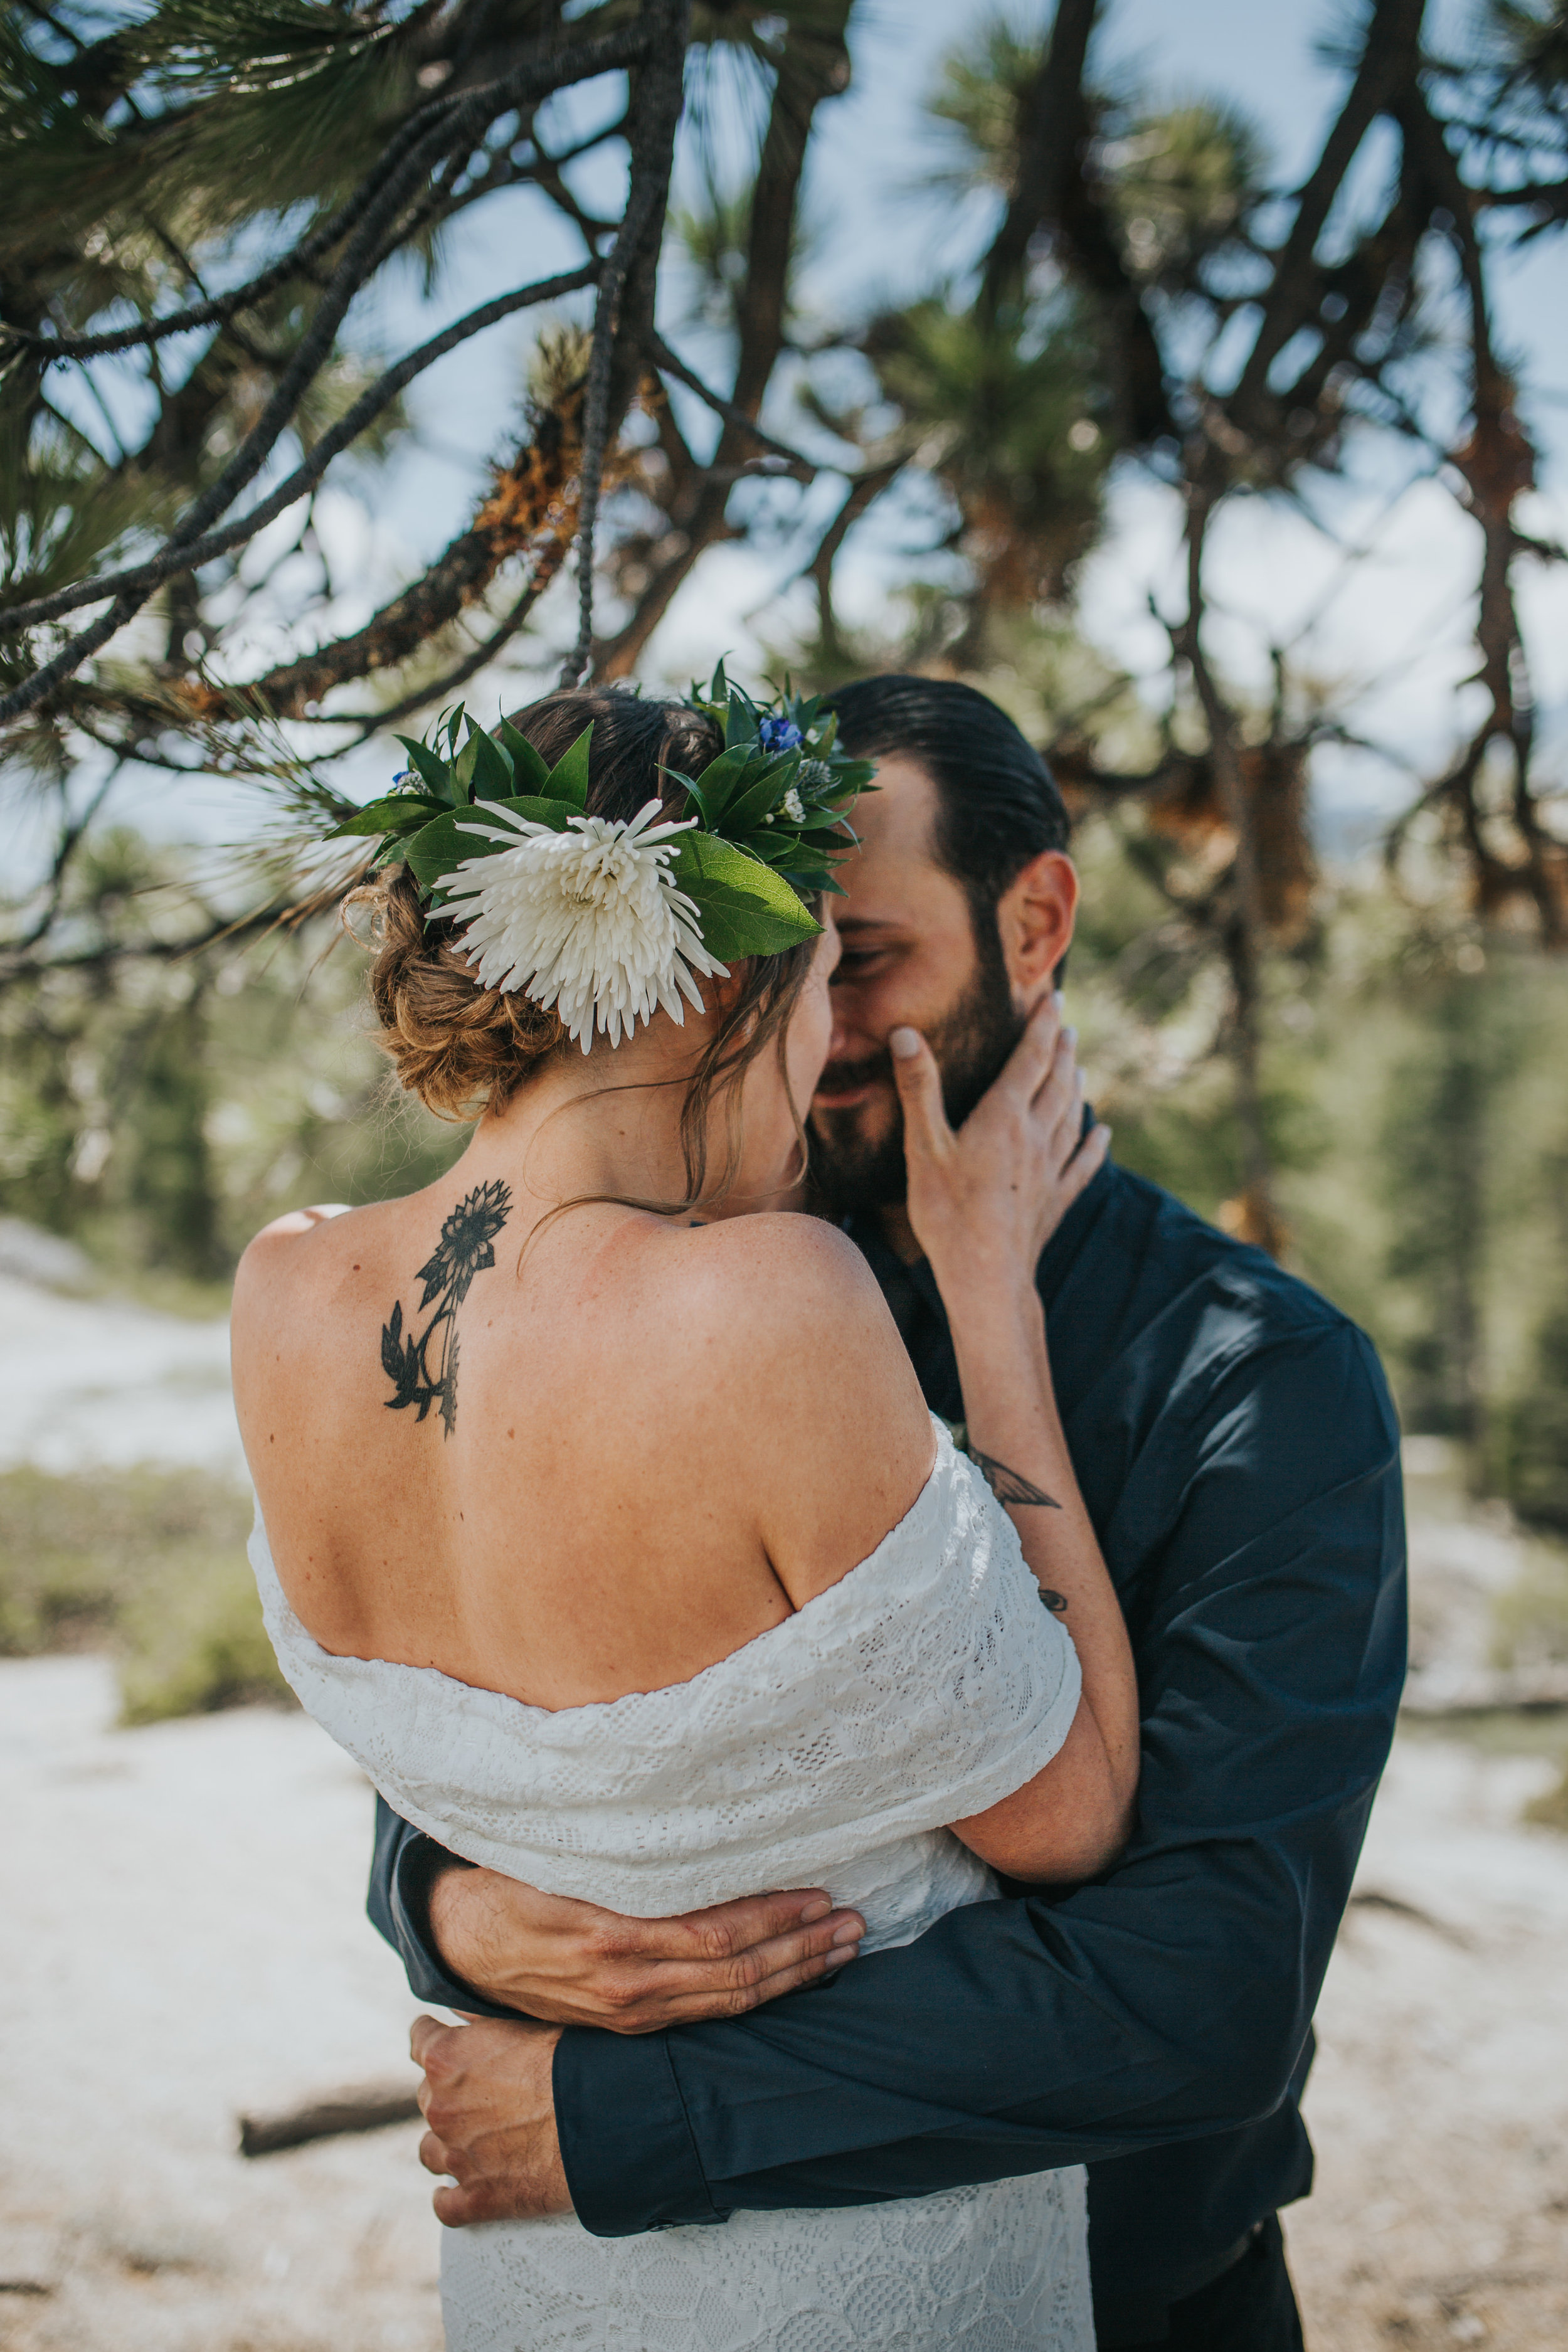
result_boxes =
[346,687,813,1207]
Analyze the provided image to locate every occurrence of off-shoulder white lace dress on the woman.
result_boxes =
[252,1423,1093,2352]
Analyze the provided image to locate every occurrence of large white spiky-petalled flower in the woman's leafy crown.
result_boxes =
[437,800,729,1051]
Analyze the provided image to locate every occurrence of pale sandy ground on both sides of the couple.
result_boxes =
[0,1285,1568,2352]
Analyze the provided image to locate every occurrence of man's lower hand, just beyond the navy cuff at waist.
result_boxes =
[409,2018,571,2230]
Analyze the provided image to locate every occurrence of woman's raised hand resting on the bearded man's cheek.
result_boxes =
[889,995,1110,1296]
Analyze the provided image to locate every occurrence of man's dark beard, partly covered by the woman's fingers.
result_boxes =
[811,922,1025,1216]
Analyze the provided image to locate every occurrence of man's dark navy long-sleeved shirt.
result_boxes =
[371,1167,1406,2336]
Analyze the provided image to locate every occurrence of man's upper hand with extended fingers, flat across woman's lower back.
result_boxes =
[430,1870,865,2035]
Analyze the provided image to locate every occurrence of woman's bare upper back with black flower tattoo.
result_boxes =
[233,1176,933,1708]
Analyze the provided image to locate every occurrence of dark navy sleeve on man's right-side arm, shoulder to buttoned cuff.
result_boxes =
[555,1322,1406,2237]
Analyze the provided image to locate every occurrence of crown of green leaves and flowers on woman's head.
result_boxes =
[329,664,872,1054]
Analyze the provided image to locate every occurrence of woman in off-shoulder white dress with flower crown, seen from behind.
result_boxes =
[233,677,1138,2352]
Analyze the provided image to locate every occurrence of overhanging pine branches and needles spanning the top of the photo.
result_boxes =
[0,0,1568,1289]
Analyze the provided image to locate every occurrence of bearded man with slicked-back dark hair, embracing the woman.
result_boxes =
[371,677,1404,2352]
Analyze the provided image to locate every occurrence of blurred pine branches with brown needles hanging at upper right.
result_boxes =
[818,0,1568,1249]
